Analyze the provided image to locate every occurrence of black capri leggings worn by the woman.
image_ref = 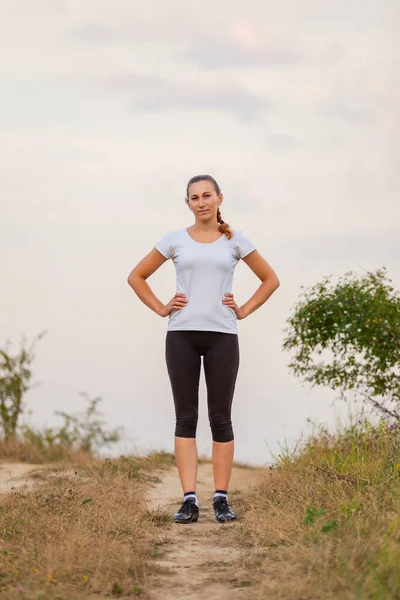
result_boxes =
[165,330,239,442]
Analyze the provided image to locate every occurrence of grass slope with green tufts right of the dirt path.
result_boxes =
[236,422,400,600]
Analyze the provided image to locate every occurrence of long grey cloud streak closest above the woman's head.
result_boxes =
[106,74,271,122]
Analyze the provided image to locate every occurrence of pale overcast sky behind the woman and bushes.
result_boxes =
[0,0,400,464]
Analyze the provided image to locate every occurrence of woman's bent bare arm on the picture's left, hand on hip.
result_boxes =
[128,248,187,317]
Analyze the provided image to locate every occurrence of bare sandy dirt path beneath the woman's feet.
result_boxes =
[148,463,266,600]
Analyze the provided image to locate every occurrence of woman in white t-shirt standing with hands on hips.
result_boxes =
[128,175,279,523]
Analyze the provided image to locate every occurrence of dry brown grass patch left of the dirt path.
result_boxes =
[0,453,174,600]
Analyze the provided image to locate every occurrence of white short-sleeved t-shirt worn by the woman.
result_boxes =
[155,228,256,333]
